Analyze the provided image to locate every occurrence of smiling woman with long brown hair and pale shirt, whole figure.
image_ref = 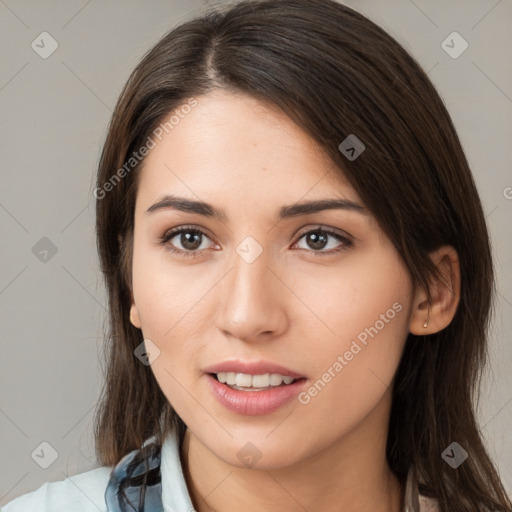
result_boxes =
[5,0,512,512]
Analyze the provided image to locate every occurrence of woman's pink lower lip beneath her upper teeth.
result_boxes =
[206,374,306,416]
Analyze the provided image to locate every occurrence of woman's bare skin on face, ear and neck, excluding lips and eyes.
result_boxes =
[130,90,460,512]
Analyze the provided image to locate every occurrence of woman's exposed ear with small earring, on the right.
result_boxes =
[409,245,460,336]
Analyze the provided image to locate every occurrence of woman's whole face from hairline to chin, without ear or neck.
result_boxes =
[131,91,413,467]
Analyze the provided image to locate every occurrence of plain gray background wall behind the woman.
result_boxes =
[0,0,512,504]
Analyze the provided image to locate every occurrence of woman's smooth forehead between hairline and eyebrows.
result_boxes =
[137,90,359,206]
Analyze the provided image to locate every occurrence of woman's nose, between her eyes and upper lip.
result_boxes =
[216,246,292,342]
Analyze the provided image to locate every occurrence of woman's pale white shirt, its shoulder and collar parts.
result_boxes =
[1,435,439,512]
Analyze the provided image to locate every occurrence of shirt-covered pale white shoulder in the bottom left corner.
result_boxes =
[1,466,112,512]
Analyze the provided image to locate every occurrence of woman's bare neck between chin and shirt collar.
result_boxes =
[180,390,404,512]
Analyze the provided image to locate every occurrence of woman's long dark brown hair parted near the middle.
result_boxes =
[94,0,512,512]
